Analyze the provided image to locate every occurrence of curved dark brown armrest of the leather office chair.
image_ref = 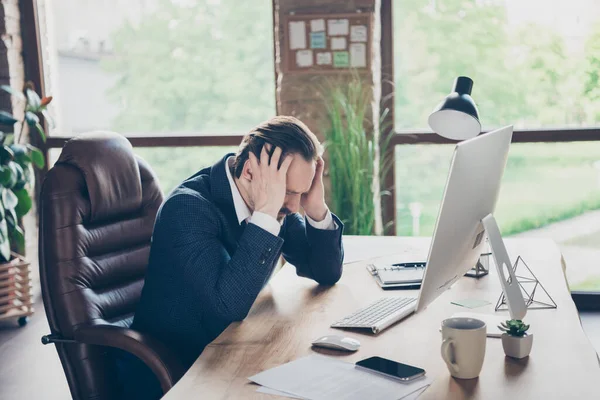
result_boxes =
[73,325,185,393]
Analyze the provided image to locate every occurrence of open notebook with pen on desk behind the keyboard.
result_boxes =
[367,262,425,289]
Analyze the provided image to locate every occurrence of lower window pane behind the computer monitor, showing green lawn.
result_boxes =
[396,142,600,291]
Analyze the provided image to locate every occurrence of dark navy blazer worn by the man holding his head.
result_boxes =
[124,154,343,392]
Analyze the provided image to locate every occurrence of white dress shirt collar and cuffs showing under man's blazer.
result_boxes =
[225,156,337,236]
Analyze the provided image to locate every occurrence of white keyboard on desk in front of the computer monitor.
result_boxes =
[331,297,417,333]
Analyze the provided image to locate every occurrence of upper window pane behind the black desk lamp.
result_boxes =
[393,0,600,131]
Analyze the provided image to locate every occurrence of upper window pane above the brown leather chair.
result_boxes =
[38,0,275,136]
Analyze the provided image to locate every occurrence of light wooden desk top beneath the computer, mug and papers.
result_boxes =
[165,237,600,399]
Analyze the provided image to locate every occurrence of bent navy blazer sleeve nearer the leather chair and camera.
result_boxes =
[155,194,283,321]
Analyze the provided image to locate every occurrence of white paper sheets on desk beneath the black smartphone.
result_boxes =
[248,355,431,400]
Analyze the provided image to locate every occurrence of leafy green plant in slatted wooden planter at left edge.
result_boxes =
[0,83,52,325]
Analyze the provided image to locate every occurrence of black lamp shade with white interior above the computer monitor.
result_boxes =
[428,76,481,140]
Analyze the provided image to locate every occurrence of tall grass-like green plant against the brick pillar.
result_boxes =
[320,71,393,235]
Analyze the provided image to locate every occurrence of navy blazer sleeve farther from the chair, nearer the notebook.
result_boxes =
[282,213,344,285]
